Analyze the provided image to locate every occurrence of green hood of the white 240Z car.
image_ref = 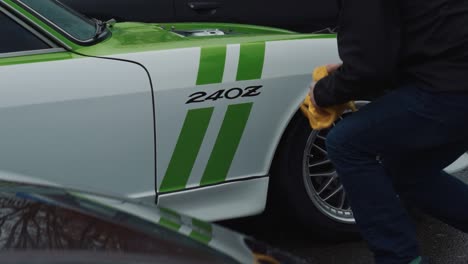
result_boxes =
[76,22,330,56]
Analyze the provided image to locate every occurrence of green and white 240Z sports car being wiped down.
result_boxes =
[0,0,466,238]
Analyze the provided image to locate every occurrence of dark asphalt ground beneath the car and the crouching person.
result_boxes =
[222,170,468,264]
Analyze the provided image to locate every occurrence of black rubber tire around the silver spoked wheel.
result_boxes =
[267,113,359,241]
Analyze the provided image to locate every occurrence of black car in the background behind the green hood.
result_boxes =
[60,0,338,32]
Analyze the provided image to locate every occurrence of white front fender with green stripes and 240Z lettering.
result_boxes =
[112,37,339,193]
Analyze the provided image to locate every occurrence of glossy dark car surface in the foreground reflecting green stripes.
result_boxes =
[0,177,305,264]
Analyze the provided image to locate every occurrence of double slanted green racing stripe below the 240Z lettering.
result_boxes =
[159,103,253,193]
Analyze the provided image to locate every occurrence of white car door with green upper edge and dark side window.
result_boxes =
[0,10,155,200]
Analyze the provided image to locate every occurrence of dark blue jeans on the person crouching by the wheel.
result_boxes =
[327,86,468,264]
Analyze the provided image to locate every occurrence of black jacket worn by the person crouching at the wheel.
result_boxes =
[314,0,468,107]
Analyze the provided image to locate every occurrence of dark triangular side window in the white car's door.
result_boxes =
[0,12,50,53]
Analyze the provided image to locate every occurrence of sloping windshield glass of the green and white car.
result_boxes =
[18,0,99,42]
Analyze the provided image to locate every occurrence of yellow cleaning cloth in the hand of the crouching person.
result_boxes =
[301,66,357,130]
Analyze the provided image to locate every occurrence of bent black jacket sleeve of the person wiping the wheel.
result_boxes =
[314,0,401,107]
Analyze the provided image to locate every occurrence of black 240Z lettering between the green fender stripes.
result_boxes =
[186,85,263,104]
